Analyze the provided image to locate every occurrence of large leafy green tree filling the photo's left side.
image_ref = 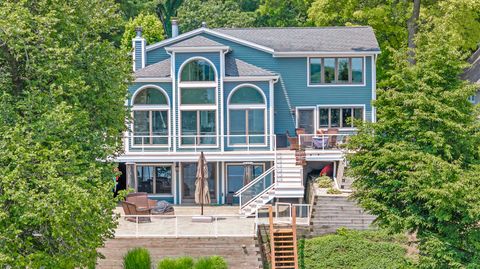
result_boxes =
[0,0,131,268]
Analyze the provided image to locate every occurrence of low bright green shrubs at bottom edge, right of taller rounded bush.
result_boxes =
[157,256,228,269]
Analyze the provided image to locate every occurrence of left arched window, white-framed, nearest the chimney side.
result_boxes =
[132,88,169,146]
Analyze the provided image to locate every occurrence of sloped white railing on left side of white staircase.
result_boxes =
[234,166,275,210]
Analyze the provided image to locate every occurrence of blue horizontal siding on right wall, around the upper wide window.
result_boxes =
[202,34,372,134]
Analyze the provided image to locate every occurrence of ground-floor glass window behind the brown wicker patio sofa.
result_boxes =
[135,164,174,196]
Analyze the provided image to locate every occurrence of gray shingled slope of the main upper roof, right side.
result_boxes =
[213,26,380,52]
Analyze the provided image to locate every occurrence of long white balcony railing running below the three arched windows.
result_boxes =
[124,133,276,152]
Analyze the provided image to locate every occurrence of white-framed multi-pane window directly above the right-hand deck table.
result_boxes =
[318,107,363,128]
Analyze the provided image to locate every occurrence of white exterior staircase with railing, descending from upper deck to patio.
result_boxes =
[235,150,305,216]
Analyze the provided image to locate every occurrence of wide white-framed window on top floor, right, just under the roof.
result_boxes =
[309,57,364,85]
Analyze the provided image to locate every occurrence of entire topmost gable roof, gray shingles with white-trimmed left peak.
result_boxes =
[146,26,380,56]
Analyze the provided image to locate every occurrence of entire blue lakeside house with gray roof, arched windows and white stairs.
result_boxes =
[118,23,380,215]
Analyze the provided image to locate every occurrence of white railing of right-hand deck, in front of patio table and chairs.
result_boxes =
[298,134,352,150]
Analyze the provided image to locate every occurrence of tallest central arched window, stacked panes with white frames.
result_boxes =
[179,59,218,146]
